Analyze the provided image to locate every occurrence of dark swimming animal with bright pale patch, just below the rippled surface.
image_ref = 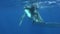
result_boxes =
[19,0,44,25]
